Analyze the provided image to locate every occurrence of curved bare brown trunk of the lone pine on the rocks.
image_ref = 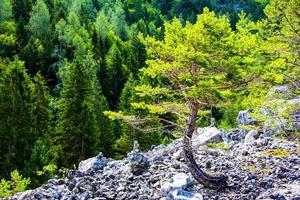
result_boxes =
[183,102,227,190]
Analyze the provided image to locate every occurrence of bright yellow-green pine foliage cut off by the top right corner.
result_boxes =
[259,0,300,83]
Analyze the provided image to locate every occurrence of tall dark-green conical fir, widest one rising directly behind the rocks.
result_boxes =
[57,60,100,166]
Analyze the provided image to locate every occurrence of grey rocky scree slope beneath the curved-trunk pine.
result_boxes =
[7,127,300,200]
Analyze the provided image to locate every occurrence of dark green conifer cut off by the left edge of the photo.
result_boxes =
[0,60,35,175]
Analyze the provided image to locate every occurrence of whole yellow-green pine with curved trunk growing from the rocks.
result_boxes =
[107,9,288,189]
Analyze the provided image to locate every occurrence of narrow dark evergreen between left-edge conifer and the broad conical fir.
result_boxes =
[25,73,51,187]
